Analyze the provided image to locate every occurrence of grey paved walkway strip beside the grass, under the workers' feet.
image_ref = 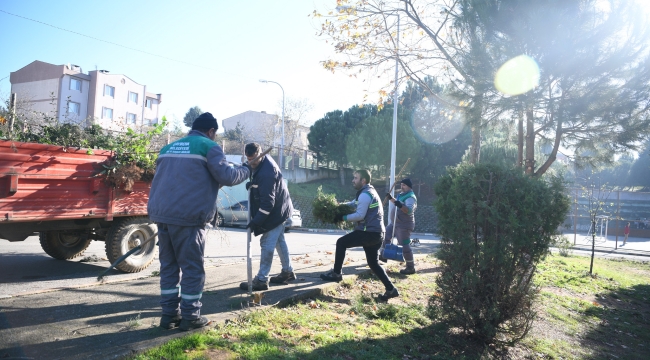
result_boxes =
[0,249,420,360]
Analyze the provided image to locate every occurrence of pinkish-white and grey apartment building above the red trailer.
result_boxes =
[10,60,162,131]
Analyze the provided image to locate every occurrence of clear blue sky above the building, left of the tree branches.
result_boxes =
[0,0,375,129]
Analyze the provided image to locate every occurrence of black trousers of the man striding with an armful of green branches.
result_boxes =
[334,230,394,291]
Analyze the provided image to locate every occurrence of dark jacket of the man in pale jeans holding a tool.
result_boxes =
[251,155,293,236]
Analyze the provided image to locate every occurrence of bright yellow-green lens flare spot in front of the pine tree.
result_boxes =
[494,55,539,95]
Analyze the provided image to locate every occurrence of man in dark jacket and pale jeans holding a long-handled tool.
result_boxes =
[239,143,296,291]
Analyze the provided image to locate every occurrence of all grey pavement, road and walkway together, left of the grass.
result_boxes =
[0,230,436,359]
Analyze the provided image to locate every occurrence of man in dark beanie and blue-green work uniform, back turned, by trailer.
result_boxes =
[147,113,250,330]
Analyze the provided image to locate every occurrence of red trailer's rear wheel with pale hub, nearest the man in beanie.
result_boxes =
[106,217,156,273]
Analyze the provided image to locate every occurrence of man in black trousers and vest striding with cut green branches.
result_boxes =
[320,169,399,301]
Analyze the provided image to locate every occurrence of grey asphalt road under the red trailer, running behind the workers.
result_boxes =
[0,228,438,298]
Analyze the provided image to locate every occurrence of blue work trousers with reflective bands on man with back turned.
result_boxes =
[158,223,206,320]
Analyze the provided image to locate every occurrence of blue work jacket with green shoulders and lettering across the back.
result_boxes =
[147,130,249,226]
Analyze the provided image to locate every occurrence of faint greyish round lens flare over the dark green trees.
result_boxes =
[411,97,465,144]
